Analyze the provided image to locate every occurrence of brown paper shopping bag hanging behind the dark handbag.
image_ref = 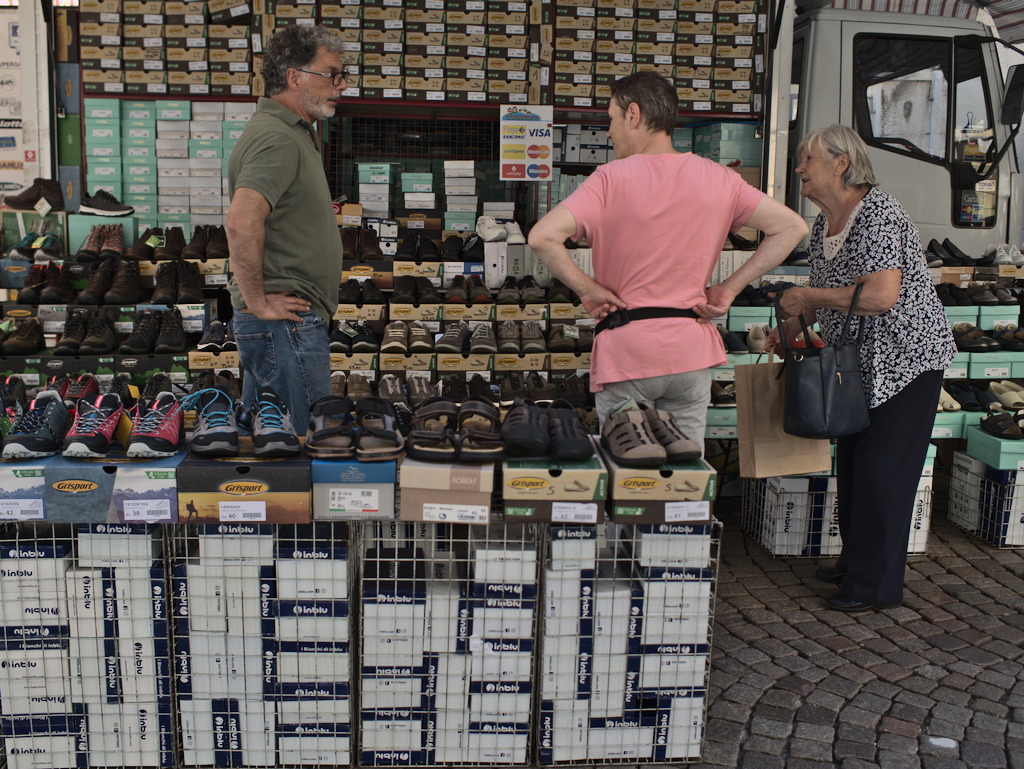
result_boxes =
[735,362,831,478]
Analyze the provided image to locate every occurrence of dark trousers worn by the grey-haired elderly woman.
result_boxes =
[836,371,943,603]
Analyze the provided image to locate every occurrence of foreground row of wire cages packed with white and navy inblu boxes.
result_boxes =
[0,520,721,769]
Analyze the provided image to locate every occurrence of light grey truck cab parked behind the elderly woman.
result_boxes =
[770,9,1022,256]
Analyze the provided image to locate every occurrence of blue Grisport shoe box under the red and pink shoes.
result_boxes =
[45,452,185,523]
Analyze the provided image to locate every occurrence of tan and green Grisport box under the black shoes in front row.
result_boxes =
[501,455,608,523]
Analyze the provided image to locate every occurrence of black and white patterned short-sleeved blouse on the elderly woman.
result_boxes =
[808,187,956,409]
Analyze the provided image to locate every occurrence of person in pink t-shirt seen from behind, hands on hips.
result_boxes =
[529,72,807,441]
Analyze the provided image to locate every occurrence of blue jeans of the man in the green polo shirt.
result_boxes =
[234,309,331,435]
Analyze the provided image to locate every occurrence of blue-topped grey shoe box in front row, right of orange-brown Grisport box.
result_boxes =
[309,459,397,520]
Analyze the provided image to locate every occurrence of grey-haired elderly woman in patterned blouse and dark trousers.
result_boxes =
[768,125,956,611]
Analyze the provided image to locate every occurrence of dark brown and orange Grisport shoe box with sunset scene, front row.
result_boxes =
[177,454,311,523]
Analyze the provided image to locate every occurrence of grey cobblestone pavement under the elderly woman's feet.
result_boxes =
[691,500,1024,769]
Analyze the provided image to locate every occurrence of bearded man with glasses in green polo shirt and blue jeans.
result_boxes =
[225,25,346,432]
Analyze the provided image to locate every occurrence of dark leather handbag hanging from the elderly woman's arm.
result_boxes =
[775,284,869,438]
